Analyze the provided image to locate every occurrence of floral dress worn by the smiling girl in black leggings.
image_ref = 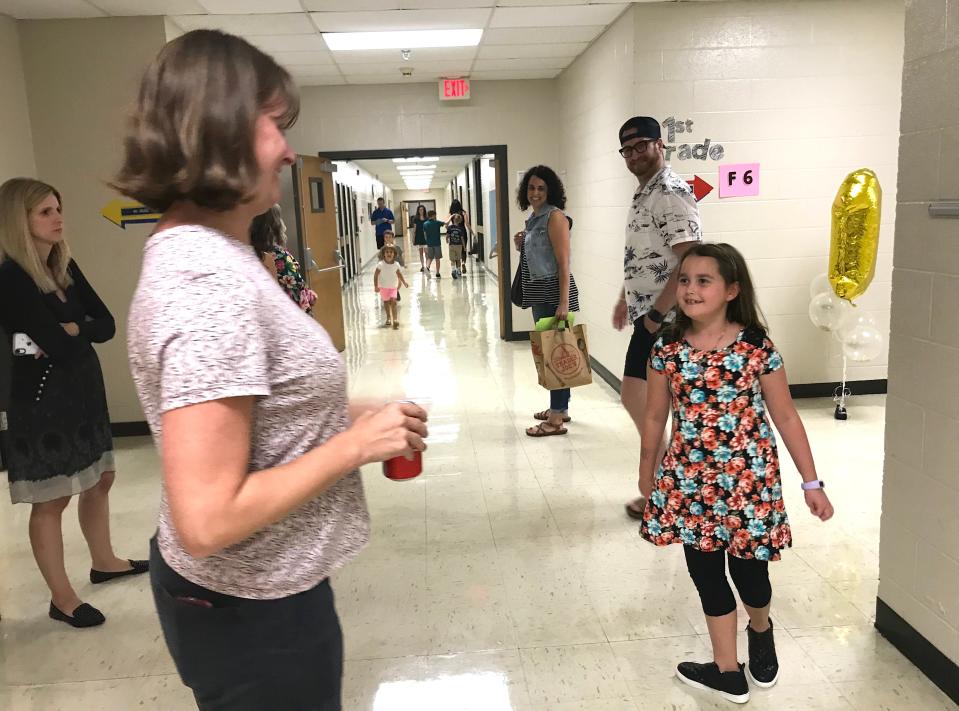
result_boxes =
[640,329,792,561]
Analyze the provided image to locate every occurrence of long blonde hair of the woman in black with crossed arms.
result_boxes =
[0,178,73,294]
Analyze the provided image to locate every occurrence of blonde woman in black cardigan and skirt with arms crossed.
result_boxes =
[0,178,148,627]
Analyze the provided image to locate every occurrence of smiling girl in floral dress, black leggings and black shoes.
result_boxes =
[639,244,833,703]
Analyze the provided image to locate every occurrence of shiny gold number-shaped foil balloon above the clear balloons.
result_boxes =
[829,168,882,301]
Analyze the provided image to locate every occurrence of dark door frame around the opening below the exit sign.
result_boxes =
[317,144,516,341]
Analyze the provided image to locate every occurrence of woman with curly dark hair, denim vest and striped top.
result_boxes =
[513,165,579,437]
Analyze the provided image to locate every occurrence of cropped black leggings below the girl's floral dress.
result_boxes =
[683,546,773,617]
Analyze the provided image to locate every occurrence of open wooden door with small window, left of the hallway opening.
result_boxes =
[294,156,346,351]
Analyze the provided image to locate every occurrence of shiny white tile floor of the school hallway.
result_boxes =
[0,262,956,711]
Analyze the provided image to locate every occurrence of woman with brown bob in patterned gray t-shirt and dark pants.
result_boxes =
[114,30,426,711]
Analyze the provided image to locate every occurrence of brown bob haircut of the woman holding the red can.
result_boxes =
[110,30,300,212]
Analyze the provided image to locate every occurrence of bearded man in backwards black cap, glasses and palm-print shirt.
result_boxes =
[613,116,702,519]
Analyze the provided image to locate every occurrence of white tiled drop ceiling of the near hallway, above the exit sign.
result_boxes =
[0,0,708,86]
